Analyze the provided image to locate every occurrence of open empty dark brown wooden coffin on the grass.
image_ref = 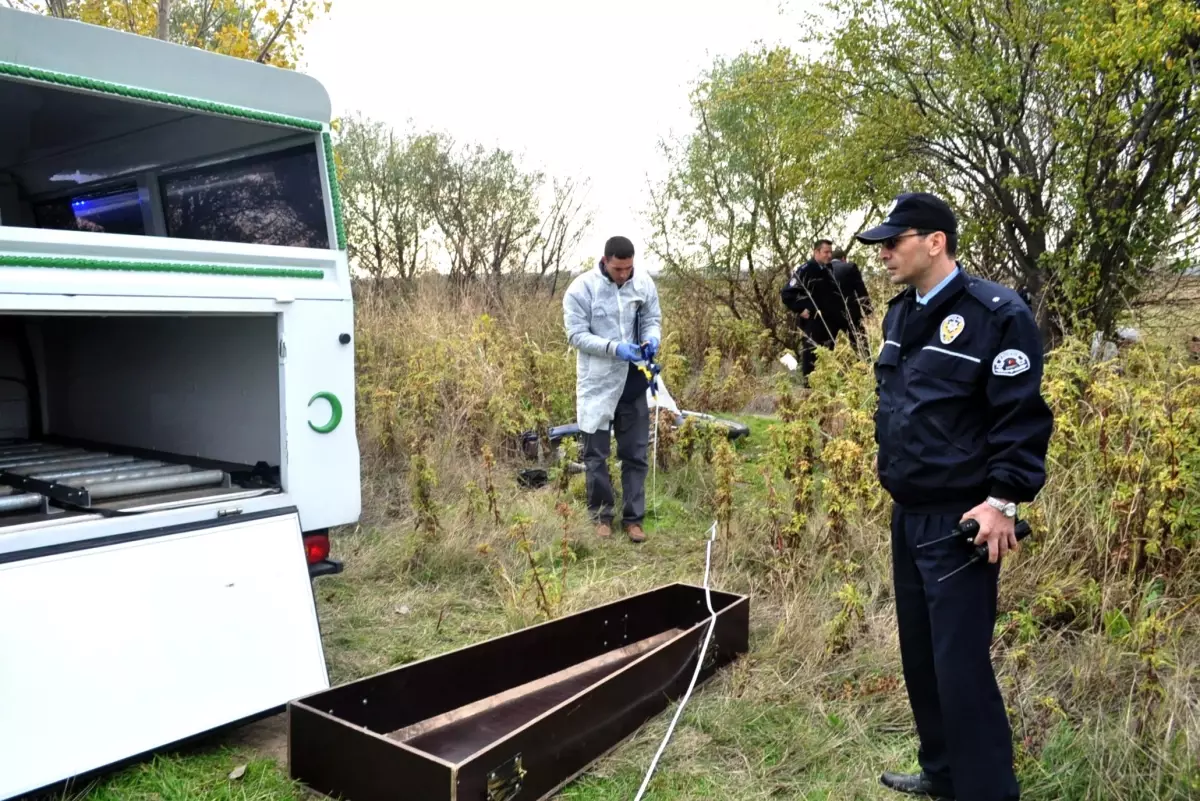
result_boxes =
[288,584,750,801]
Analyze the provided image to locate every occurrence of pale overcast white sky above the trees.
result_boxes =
[302,0,816,267]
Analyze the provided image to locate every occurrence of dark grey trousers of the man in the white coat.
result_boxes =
[583,380,650,525]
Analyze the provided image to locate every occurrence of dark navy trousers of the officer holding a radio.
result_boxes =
[892,506,1020,801]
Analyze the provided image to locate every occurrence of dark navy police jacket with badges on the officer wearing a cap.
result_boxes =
[875,271,1054,514]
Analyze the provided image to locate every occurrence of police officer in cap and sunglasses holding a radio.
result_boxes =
[858,193,1054,801]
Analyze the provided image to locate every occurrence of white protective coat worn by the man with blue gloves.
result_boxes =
[563,266,662,434]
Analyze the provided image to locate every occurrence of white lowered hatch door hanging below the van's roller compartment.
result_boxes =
[0,510,329,799]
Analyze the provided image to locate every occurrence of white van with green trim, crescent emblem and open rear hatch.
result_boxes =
[0,7,361,799]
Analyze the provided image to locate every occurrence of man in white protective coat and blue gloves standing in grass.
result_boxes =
[563,236,662,542]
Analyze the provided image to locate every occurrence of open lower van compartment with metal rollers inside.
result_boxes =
[0,314,281,535]
